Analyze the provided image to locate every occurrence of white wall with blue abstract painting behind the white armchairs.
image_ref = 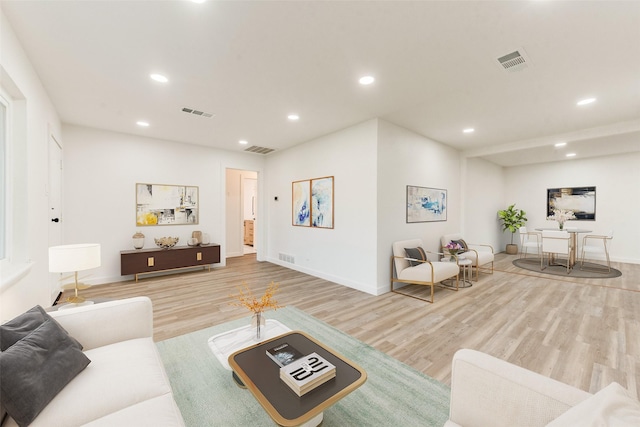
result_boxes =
[377,120,462,294]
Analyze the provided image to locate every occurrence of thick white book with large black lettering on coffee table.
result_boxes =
[280,353,336,396]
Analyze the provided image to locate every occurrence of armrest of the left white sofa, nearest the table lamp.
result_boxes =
[49,297,153,350]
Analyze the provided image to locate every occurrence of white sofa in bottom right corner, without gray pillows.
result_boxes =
[445,349,640,427]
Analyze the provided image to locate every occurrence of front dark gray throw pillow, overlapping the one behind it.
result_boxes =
[0,319,91,427]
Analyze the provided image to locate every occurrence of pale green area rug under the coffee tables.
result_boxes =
[157,307,451,427]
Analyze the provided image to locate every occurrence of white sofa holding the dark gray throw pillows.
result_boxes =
[3,297,184,427]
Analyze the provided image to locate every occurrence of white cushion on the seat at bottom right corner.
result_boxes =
[547,382,640,427]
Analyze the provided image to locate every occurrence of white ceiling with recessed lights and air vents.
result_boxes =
[0,0,640,166]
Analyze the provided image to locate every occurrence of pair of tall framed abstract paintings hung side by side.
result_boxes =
[291,176,333,228]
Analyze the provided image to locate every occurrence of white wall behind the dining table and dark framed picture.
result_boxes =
[505,152,640,264]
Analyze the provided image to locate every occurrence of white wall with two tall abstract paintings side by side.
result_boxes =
[260,120,377,294]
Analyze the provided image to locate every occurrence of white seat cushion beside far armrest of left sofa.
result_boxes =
[24,338,171,427]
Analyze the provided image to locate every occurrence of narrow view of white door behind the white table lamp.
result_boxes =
[47,135,62,303]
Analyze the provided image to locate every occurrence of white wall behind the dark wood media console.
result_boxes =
[62,125,264,283]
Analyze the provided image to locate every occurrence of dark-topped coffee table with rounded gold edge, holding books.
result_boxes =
[229,331,367,426]
